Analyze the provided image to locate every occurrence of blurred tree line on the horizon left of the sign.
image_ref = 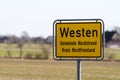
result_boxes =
[0,32,53,44]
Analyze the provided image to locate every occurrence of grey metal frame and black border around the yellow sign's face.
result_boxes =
[53,19,105,60]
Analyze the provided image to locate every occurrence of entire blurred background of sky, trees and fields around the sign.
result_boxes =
[0,0,120,80]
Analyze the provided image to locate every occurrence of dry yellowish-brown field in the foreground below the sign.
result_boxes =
[0,59,120,80]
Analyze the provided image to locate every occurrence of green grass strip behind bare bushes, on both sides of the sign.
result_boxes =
[0,43,120,60]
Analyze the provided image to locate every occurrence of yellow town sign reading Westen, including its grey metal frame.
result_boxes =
[54,20,103,59]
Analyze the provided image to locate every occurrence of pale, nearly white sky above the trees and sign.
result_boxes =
[0,0,120,37]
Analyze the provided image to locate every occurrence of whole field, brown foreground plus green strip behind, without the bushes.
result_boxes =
[0,44,120,80]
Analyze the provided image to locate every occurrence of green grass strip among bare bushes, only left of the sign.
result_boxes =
[0,43,52,57]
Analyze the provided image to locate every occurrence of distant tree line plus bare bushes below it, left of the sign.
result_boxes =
[0,32,53,59]
